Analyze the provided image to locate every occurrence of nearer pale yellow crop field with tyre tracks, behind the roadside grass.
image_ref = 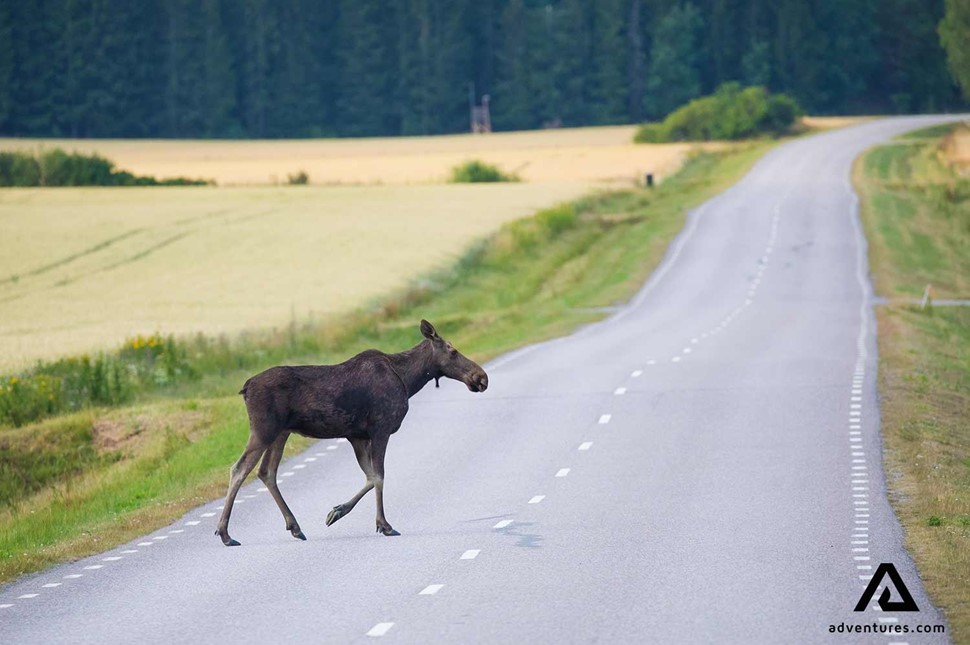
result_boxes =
[0,183,587,373]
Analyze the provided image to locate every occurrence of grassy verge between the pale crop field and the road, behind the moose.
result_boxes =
[0,142,774,582]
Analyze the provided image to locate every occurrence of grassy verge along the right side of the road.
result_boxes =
[854,126,970,642]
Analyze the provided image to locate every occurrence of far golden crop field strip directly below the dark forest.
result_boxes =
[0,126,721,186]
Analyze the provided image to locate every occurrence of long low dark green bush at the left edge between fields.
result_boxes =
[0,148,212,186]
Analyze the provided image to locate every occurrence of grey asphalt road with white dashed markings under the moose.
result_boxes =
[0,118,946,643]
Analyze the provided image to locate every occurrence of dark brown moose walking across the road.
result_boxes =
[216,320,488,546]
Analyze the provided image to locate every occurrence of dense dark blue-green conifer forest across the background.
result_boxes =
[0,0,961,137]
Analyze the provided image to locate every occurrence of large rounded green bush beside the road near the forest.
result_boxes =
[633,83,801,143]
